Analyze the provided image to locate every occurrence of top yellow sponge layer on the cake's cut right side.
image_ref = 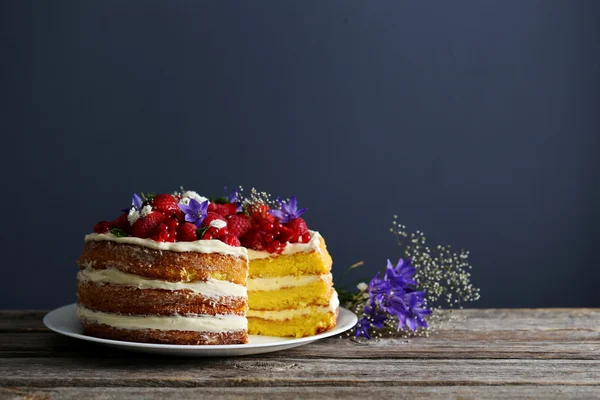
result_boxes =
[249,238,333,278]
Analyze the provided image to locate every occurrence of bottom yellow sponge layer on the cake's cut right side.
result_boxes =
[248,312,336,337]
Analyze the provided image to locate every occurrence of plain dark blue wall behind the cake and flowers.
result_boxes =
[5,0,600,308]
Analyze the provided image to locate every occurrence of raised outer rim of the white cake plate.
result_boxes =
[42,303,358,350]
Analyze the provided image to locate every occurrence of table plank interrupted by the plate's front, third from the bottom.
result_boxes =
[0,330,600,360]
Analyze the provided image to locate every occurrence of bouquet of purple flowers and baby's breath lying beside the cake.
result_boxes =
[338,216,479,339]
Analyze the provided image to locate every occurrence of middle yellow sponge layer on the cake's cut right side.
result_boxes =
[248,279,333,310]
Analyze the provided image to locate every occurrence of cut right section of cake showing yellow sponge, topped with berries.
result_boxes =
[242,197,339,337]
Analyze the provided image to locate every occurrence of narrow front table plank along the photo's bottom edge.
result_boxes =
[0,385,600,400]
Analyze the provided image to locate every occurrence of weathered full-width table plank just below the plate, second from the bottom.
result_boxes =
[0,357,600,388]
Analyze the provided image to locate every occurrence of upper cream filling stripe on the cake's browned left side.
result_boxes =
[77,267,248,298]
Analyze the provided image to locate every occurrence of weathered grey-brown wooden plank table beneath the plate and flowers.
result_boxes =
[0,309,600,399]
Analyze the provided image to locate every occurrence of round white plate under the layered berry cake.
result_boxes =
[44,304,357,357]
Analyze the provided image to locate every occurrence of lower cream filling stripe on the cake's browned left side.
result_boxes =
[77,306,248,333]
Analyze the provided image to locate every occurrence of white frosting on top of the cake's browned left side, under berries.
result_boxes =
[85,233,247,259]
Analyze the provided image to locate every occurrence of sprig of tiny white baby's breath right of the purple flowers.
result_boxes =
[390,215,480,309]
